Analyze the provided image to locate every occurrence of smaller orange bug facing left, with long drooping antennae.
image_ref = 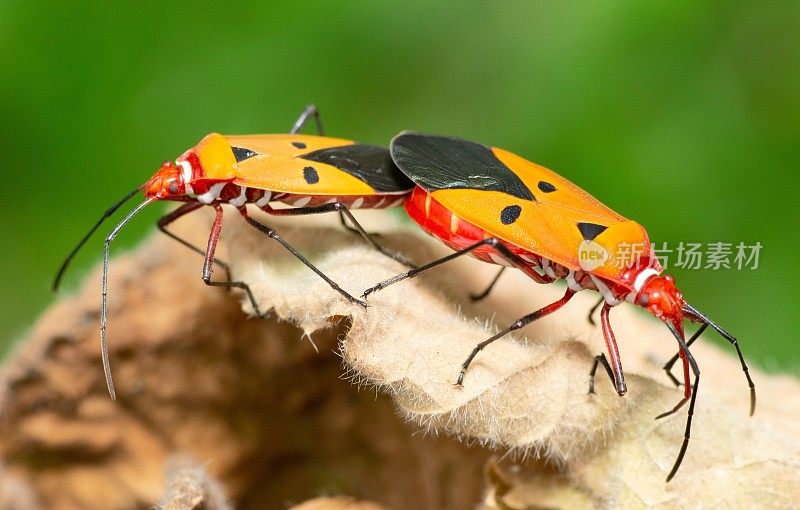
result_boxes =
[53,105,414,399]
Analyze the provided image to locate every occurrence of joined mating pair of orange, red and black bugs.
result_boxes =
[54,106,755,481]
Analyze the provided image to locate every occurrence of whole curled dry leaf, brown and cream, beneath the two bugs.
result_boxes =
[0,208,800,508]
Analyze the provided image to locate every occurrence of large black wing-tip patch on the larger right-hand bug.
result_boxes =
[390,132,536,200]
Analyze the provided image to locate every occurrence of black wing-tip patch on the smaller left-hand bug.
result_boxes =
[300,143,414,193]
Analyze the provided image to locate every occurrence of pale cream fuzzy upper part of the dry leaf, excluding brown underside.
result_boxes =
[232,208,800,508]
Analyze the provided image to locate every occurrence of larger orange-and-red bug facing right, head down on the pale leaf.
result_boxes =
[363,132,756,481]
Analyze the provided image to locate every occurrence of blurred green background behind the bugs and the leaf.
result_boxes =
[0,1,800,371]
